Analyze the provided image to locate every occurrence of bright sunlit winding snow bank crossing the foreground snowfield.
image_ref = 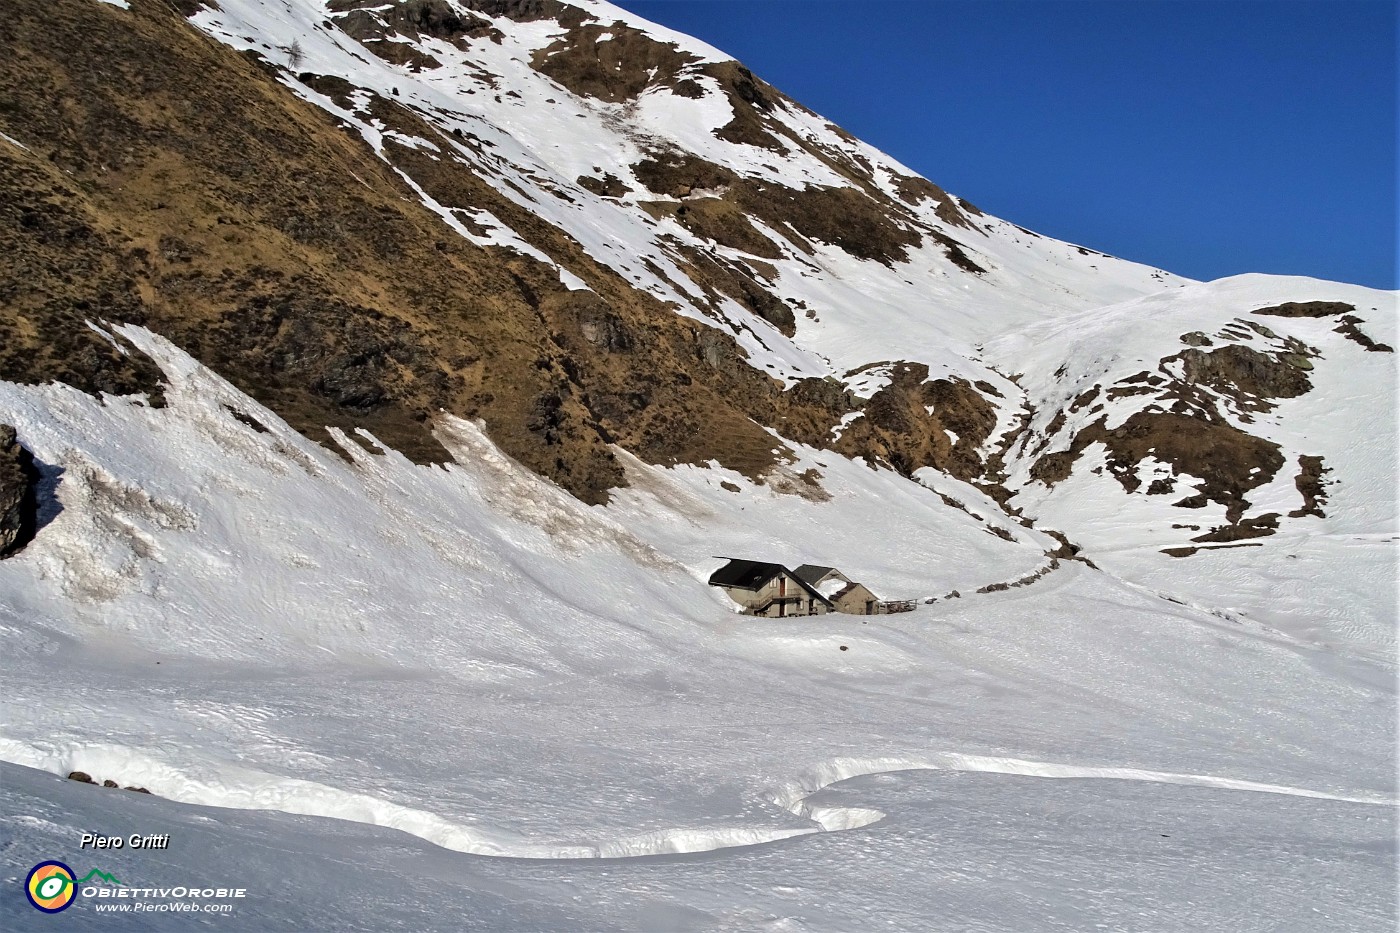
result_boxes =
[0,737,1400,860]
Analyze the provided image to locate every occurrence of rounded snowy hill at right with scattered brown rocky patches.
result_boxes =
[987,276,1400,658]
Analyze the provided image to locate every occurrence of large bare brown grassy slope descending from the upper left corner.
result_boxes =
[0,0,844,502]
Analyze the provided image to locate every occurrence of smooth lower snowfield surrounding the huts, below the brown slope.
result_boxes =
[0,326,1396,930]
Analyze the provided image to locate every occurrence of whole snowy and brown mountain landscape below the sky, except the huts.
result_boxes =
[0,0,1400,930]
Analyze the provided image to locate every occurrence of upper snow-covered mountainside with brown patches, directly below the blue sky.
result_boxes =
[193,0,1183,378]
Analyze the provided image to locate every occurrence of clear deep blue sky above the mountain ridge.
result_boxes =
[619,0,1397,289]
